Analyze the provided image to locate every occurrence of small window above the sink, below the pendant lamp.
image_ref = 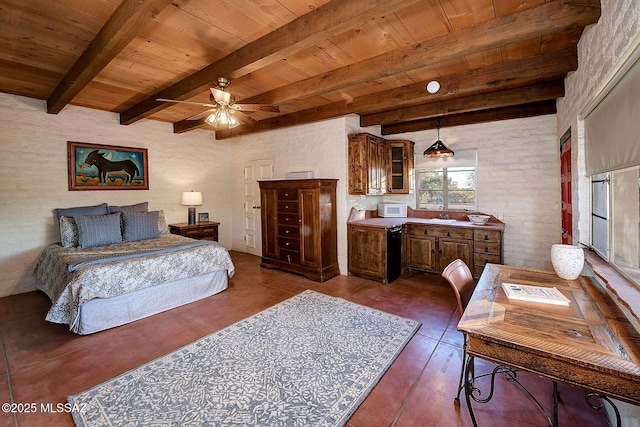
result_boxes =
[416,166,477,211]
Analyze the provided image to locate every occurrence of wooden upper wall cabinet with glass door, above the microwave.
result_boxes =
[348,133,414,195]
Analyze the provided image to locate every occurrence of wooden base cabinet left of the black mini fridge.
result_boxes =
[347,224,387,283]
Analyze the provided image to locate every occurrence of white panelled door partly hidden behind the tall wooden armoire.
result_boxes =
[244,159,273,256]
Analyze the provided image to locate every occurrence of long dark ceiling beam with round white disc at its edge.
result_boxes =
[174,48,578,136]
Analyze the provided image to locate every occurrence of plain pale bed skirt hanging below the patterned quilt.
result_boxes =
[71,270,229,335]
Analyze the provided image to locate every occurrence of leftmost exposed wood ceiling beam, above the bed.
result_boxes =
[47,0,172,114]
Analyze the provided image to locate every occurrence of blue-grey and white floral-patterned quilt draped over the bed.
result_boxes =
[33,234,234,328]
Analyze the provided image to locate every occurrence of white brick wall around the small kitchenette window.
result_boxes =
[370,115,561,270]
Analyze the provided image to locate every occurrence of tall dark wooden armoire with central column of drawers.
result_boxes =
[259,179,340,282]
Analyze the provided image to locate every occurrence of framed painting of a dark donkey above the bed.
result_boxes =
[67,141,149,191]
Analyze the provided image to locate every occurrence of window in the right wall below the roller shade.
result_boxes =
[591,166,640,285]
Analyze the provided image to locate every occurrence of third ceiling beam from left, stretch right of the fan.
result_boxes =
[236,0,600,104]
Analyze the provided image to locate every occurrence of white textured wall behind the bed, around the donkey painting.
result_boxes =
[0,94,231,296]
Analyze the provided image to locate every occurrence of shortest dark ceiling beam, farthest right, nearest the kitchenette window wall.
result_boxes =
[380,100,557,135]
